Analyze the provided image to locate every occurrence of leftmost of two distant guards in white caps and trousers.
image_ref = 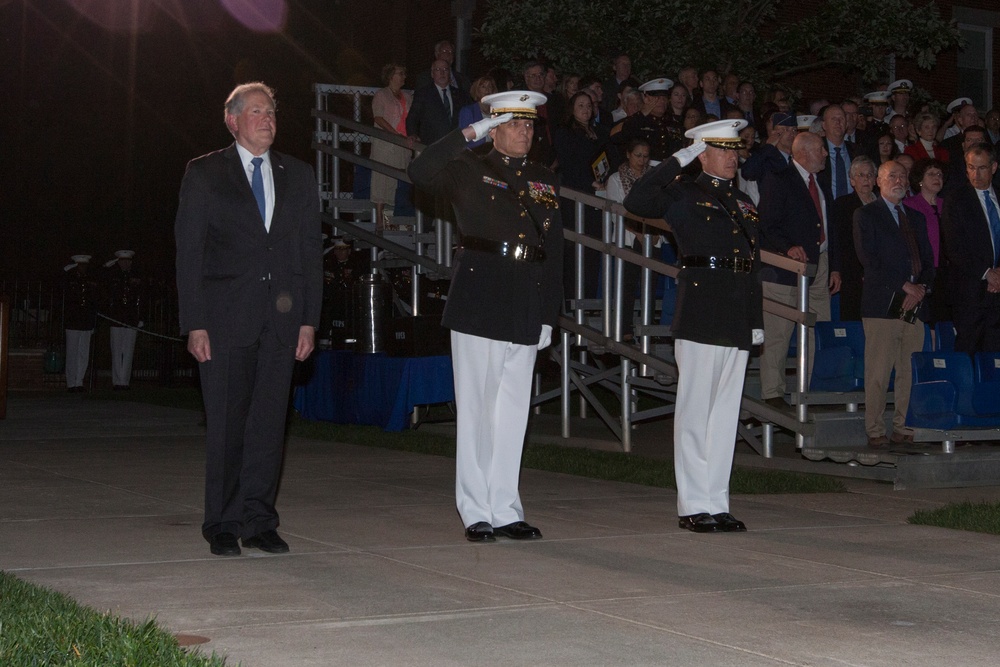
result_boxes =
[63,255,98,393]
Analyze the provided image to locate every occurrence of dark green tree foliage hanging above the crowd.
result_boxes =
[479,0,961,83]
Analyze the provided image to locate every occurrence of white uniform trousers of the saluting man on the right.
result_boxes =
[674,340,750,516]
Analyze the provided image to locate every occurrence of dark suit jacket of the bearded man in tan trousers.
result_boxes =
[854,197,934,321]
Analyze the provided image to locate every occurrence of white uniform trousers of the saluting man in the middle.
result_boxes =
[451,331,538,527]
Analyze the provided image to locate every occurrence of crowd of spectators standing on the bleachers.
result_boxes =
[380,42,1000,358]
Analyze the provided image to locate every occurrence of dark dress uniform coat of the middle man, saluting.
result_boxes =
[408,130,563,345]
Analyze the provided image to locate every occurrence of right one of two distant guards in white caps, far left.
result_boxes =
[105,250,142,391]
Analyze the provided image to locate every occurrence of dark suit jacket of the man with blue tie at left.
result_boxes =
[175,144,323,347]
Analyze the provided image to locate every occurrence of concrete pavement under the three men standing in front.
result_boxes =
[0,394,1000,667]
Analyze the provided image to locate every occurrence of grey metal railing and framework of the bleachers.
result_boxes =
[312,84,815,457]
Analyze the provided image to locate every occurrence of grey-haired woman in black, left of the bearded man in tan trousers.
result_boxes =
[833,155,878,321]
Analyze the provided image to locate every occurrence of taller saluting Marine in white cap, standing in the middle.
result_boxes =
[409,91,563,542]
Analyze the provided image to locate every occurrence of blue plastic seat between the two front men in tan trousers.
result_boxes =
[809,321,865,391]
